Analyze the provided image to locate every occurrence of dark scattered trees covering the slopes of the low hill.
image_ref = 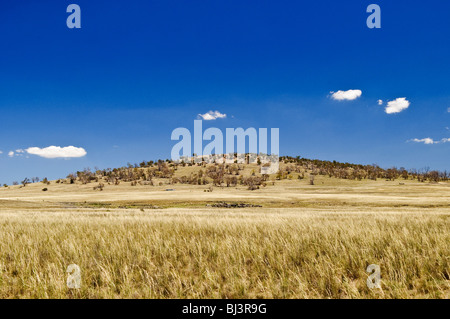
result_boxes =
[4,156,450,190]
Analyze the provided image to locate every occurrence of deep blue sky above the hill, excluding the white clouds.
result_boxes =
[0,0,450,183]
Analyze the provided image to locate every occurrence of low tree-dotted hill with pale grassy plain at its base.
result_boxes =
[0,157,450,209]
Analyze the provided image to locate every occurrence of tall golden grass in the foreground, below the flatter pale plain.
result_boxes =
[0,209,450,298]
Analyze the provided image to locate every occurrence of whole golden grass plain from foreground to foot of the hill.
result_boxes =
[0,172,450,298]
